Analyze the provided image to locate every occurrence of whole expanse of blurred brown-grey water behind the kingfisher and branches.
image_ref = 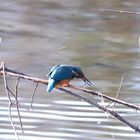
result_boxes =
[0,0,140,140]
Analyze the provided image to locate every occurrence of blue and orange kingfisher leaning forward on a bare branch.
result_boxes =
[47,65,92,92]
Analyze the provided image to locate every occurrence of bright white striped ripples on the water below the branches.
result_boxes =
[0,98,140,140]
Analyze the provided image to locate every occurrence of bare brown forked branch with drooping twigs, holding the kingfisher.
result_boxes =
[0,63,140,135]
